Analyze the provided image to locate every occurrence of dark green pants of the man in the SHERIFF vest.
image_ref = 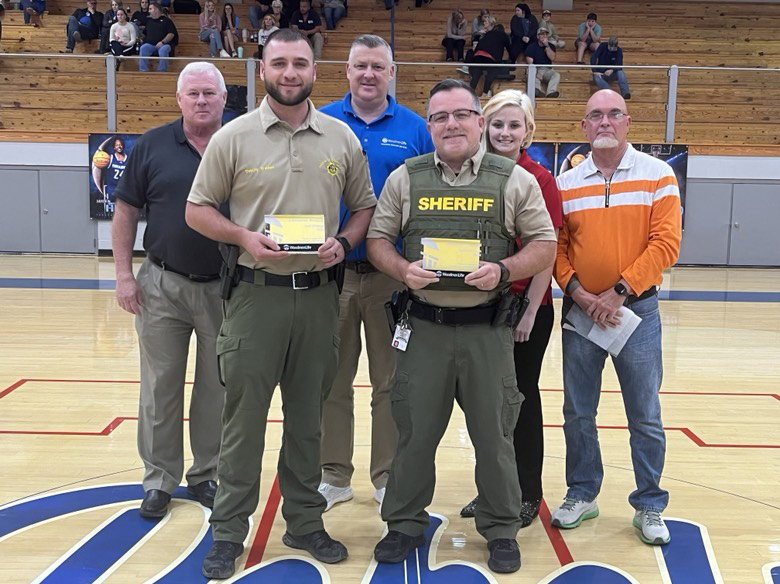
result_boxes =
[382,317,523,541]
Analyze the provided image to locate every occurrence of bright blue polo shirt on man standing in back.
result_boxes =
[320,93,433,261]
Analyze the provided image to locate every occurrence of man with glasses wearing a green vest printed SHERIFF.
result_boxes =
[367,79,555,572]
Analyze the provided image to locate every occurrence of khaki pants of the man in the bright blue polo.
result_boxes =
[322,268,403,489]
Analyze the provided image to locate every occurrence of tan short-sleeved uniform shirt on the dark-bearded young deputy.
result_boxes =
[188,97,376,274]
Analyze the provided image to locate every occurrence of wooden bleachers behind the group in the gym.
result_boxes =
[0,0,780,154]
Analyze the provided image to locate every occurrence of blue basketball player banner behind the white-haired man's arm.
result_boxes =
[89,134,140,219]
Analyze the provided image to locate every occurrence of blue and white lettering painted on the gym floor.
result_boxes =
[0,484,748,584]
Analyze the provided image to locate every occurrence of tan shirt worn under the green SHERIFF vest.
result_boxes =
[367,147,555,308]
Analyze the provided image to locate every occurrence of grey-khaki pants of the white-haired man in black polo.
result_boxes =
[135,260,225,493]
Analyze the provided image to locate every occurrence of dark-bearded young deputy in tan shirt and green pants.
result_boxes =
[187,29,376,578]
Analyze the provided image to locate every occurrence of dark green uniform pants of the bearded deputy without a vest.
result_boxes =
[210,282,339,543]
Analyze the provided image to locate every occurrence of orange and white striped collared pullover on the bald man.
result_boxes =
[555,144,682,295]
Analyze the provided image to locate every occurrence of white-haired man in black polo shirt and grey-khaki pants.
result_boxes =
[112,62,227,518]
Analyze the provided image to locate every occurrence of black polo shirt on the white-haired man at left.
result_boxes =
[114,118,221,276]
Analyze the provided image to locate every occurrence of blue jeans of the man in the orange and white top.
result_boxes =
[563,295,669,511]
